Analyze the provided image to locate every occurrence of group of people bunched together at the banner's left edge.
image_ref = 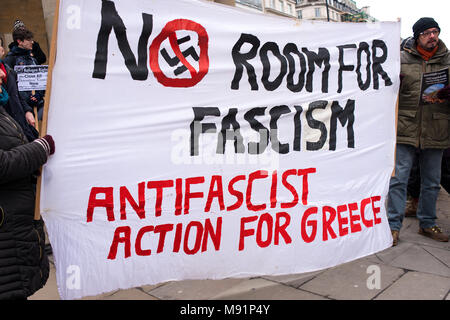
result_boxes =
[0,21,55,300]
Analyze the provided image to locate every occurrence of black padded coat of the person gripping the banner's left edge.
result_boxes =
[0,106,49,300]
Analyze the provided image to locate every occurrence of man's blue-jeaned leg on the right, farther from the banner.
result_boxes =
[417,149,443,228]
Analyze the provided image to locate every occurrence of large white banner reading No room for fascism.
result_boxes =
[40,0,400,299]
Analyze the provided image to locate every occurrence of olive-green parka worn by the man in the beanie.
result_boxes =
[397,38,450,149]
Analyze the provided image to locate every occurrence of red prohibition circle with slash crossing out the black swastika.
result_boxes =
[150,19,209,88]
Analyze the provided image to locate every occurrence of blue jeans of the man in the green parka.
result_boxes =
[388,144,444,231]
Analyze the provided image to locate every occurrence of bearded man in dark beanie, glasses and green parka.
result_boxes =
[388,18,450,246]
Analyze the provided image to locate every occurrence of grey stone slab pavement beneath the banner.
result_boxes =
[29,190,450,300]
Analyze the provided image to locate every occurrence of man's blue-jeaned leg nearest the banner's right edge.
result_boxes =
[388,144,416,231]
